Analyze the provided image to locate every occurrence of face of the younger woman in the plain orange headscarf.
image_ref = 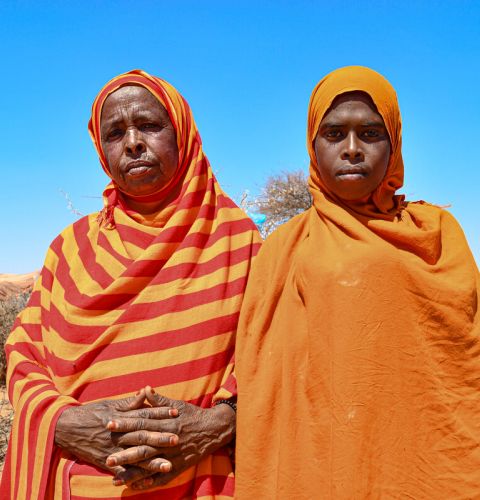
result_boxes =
[314,92,390,200]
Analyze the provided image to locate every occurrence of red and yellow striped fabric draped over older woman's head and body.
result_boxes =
[0,71,260,500]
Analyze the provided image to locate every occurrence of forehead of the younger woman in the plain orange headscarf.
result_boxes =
[322,92,383,123]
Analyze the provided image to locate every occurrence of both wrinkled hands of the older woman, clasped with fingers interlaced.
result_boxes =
[55,386,235,489]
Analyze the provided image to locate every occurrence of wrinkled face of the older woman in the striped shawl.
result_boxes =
[100,86,178,196]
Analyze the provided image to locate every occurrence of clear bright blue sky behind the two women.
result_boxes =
[0,0,480,273]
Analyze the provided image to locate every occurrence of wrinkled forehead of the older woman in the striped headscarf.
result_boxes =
[100,85,166,123]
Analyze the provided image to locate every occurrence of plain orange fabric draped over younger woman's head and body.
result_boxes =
[235,67,480,500]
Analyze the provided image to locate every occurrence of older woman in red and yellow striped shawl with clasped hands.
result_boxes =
[1,71,259,500]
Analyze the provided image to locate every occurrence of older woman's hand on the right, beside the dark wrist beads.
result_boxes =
[107,386,235,489]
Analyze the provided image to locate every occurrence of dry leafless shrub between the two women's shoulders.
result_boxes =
[251,170,312,237]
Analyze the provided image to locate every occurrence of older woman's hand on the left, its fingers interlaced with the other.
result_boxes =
[55,389,178,479]
